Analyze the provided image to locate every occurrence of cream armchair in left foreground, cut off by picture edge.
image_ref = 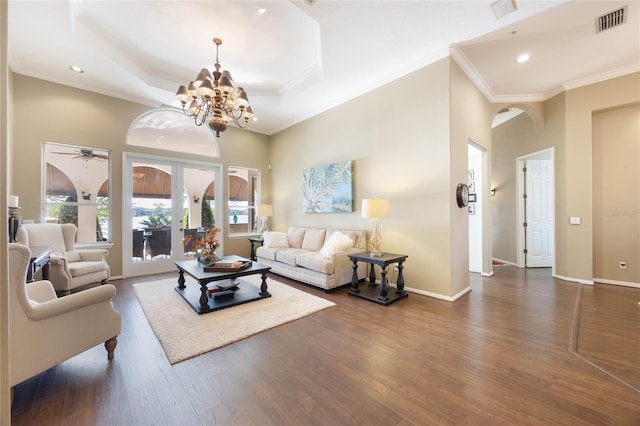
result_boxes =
[9,243,121,387]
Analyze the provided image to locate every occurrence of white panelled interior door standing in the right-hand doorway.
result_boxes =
[525,159,554,268]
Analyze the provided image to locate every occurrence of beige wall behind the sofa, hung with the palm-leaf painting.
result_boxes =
[271,59,468,297]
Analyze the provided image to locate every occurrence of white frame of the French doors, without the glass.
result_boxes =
[122,152,226,277]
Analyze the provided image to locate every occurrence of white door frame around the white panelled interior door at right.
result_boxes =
[516,148,556,275]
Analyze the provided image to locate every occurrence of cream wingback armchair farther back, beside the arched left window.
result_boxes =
[18,223,111,295]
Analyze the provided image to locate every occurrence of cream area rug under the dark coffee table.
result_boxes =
[133,275,335,364]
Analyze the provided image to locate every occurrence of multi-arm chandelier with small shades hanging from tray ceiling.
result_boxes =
[176,38,253,137]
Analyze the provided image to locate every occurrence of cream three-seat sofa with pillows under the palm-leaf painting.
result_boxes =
[256,226,367,291]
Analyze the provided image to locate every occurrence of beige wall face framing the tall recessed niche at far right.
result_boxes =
[556,73,640,282]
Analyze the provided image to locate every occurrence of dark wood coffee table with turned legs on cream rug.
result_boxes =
[176,256,271,314]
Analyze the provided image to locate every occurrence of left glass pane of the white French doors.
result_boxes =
[131,162,172,262]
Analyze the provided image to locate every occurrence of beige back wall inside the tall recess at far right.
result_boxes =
[592,105,640,285]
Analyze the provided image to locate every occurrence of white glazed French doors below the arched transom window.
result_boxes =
[122,153,223,277]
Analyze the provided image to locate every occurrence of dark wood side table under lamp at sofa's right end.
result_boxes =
[348,252,409,306]
